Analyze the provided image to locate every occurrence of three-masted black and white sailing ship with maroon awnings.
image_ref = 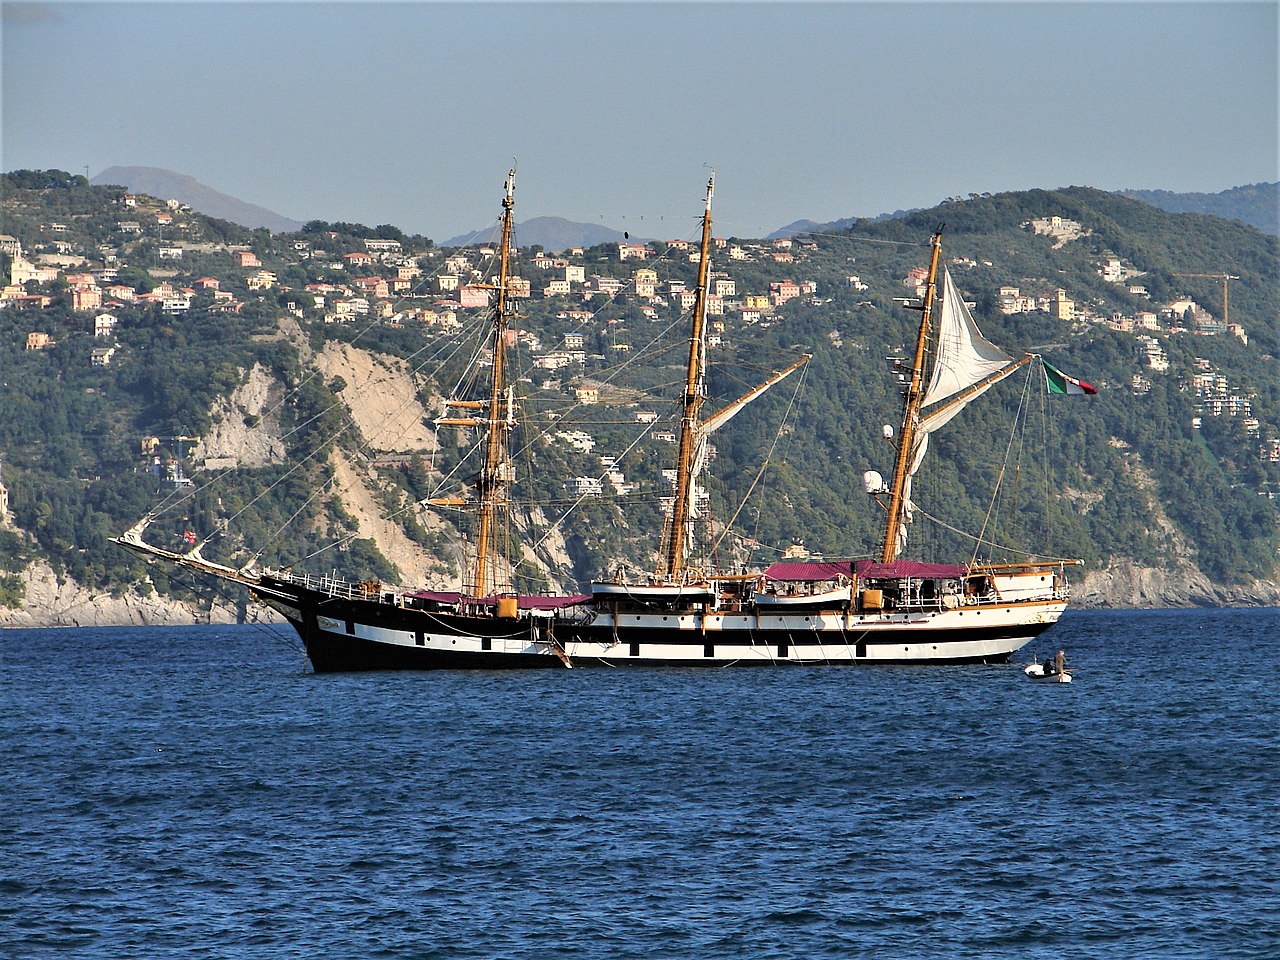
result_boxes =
[115,170,1074,673]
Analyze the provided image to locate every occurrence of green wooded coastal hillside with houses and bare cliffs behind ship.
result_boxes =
[0,172,1280,622]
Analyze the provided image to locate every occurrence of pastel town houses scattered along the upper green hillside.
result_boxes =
[0,193,1280,483]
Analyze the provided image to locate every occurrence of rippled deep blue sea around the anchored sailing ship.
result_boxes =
[0,609,1280,960]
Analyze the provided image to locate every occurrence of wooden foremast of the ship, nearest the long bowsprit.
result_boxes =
[470,169,516,596]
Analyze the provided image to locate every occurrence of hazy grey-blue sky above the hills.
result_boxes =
[3,3,1280,241]
